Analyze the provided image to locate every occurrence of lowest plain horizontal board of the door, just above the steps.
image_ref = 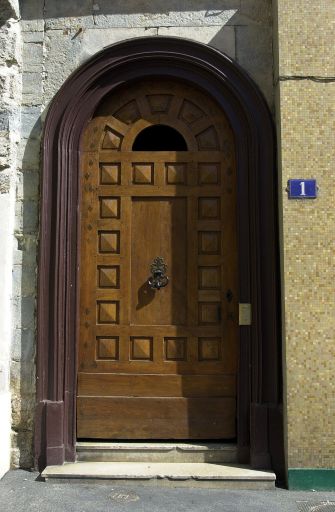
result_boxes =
[77,396,236,439]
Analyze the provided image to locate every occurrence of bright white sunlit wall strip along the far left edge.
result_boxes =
[0,1,21,478]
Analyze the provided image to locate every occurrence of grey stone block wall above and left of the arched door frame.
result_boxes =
[12,0,273,467]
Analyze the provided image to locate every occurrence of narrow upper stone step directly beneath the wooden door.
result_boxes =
[76,442,237,463]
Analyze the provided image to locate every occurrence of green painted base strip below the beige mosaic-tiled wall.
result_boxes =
[288,468,335,491]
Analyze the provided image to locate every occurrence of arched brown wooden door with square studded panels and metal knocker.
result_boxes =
[77,81,238,439]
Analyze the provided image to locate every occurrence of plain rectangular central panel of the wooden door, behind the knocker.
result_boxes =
[130,197,187,325]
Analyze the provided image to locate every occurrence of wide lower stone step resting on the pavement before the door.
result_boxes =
[41,462,276,490]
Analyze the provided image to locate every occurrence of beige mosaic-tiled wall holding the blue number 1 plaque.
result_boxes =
[276,0,335,475]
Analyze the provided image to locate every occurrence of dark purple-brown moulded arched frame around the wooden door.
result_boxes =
[35,36,284,476]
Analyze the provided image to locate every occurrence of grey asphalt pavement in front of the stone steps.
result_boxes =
[0,470,335,512]
